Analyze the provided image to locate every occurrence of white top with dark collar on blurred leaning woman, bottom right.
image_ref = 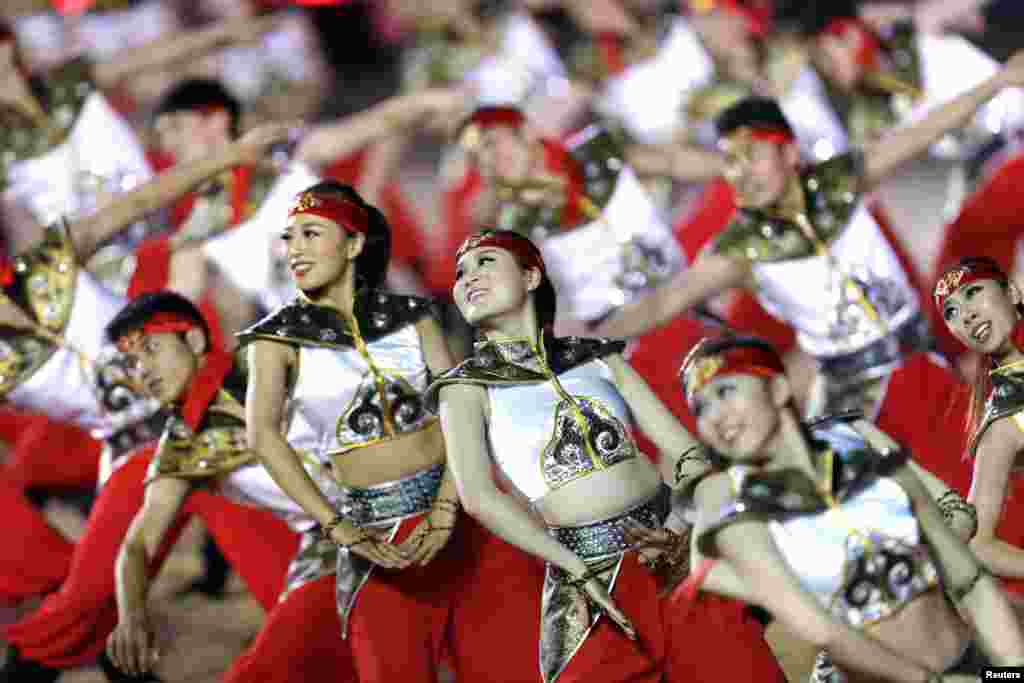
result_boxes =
[700,423,938,628]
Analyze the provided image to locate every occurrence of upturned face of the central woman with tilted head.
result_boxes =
[452,247,541,327]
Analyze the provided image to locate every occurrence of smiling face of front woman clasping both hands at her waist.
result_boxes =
[281,213,365,294]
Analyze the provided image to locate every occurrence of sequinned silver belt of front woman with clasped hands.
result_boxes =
[335,464,444,526]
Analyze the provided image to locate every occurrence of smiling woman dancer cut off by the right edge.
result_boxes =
[935,258,1024,596]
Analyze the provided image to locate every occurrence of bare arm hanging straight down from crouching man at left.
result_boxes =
[106,477,190,676]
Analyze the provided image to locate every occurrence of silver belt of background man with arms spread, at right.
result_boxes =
[818,313,933,386]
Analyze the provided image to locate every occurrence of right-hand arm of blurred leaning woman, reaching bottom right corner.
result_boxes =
[895,467,1024,667]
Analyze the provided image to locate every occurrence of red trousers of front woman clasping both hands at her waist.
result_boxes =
[224,516,491,683]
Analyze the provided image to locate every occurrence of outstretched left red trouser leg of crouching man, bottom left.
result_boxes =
[4,451,192,669]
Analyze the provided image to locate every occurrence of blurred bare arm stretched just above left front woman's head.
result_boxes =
[295,89,465,166]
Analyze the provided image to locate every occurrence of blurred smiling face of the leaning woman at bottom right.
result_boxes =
[691,375,787,463]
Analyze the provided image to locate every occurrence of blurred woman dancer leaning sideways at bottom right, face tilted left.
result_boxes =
[682,338,1024,682]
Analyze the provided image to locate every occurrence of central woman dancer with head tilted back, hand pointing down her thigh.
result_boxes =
[428,230,771,683]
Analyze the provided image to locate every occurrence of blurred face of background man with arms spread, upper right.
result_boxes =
[723,139,800,209]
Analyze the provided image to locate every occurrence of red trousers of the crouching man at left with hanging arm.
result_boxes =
[4,453,297,669]
